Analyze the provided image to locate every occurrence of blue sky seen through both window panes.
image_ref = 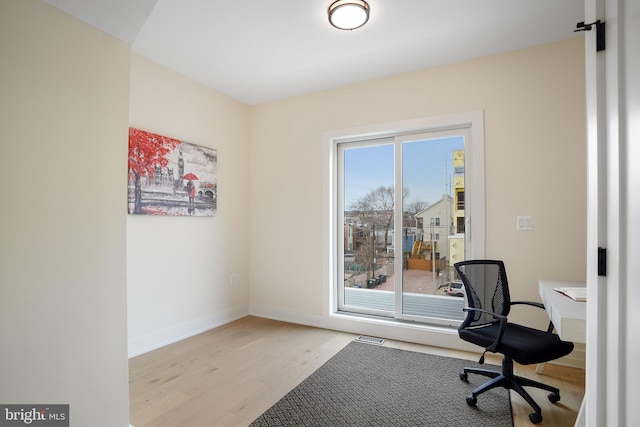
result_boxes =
[344,136,464,209]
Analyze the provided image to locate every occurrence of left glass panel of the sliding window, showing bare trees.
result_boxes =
[340,139,395,316]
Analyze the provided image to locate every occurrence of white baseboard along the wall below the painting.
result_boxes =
[128,306,249,358]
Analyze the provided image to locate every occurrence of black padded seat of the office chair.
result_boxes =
[459,323,573,365]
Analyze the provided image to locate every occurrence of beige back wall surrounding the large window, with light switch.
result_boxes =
[249,38,586,336]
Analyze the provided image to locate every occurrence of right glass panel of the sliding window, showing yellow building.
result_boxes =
[395,132,465,324]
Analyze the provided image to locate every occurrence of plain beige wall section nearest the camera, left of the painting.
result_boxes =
[0,0,130,427]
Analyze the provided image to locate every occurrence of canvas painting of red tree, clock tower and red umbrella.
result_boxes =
[128,128,218,216]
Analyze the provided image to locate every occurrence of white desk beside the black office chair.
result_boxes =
[538,280,587,344]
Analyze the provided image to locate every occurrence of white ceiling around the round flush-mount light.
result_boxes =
[44,0,584,105]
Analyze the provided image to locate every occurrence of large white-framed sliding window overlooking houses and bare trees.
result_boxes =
[326,113,484,325]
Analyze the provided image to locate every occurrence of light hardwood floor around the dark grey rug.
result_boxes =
[129,317,584,427]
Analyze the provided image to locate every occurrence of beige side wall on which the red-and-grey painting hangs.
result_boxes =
[123,54,250,355]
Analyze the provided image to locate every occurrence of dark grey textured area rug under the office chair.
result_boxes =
[251,342,513,427]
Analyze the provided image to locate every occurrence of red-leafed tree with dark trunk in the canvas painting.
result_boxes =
[129,128,181,214]
